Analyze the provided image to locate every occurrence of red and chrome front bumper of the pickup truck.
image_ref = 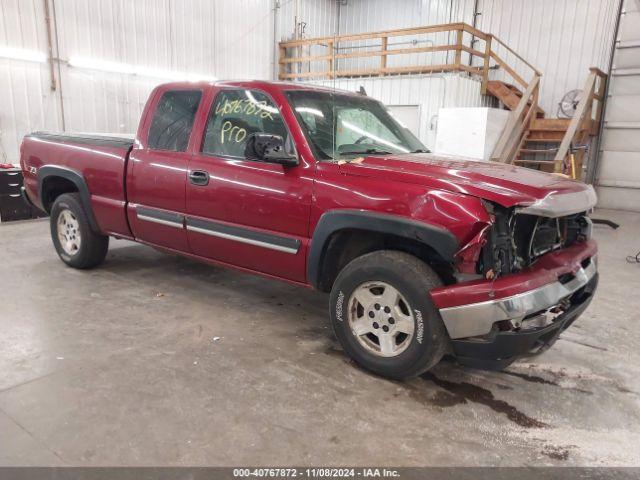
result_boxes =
[431,241,598,368]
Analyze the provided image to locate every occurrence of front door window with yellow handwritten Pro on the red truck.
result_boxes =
[202,90,289,158]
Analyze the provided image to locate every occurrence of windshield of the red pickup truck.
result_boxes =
[287,90,428,160]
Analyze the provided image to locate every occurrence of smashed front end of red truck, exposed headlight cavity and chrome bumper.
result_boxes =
[432,193,598,368]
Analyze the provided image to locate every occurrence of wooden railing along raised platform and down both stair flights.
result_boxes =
[278,23,542,163]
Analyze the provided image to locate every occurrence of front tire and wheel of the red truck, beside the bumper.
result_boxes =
[330,250,450,380]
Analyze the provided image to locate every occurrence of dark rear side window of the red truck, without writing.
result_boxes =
[149,90,202,152]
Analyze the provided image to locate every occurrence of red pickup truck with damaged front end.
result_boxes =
[21,81,598,378]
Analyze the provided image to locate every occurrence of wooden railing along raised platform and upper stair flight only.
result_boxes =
[278,23,540,91]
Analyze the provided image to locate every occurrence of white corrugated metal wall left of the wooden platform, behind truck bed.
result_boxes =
[0,0,276,162]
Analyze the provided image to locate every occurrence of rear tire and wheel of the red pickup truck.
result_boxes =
[50,193,109,269]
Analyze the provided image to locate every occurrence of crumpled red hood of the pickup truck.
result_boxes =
[340,153,591,207]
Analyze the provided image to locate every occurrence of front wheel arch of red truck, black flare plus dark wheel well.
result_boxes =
[307,210,458,292]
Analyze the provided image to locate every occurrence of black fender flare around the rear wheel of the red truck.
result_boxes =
[38,165,100,232]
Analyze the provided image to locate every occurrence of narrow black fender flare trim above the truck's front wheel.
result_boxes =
[307,210,458,288]
